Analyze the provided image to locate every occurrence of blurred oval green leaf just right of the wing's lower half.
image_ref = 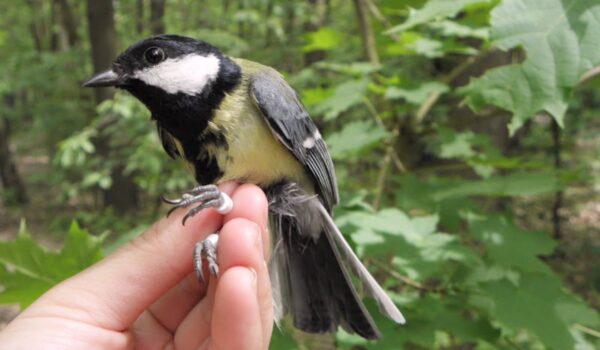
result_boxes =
[327,121,389,159]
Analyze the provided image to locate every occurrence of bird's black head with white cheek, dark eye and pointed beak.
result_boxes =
[83,35,240,115]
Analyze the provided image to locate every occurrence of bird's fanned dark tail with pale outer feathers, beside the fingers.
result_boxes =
[267,184,404,339]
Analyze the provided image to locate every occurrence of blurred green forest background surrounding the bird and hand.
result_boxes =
[0,0,600,350]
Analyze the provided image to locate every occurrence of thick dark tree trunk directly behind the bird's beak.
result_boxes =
[87,0,138,212]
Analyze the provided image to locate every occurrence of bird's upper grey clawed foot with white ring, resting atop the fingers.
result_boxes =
[163,185,233,225]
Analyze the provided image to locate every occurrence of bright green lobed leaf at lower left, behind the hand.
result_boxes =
[0,223,102,308]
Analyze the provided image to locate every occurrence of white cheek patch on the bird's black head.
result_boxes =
[133,54,220,95]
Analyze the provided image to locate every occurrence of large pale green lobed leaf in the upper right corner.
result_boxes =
[461,0,600,133]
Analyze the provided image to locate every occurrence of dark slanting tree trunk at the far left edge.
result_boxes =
[0,95,28,204]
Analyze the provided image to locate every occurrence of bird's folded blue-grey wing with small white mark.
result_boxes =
[250,68,339,211]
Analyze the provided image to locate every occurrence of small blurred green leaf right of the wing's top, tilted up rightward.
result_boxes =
[313,79,369,120]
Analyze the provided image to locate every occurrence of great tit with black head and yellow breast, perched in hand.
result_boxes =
[84,35,405,339]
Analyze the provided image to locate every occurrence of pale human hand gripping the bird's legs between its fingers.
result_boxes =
[0,183,273,350]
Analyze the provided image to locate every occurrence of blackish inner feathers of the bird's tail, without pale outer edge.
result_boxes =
[278,209,380,339]
